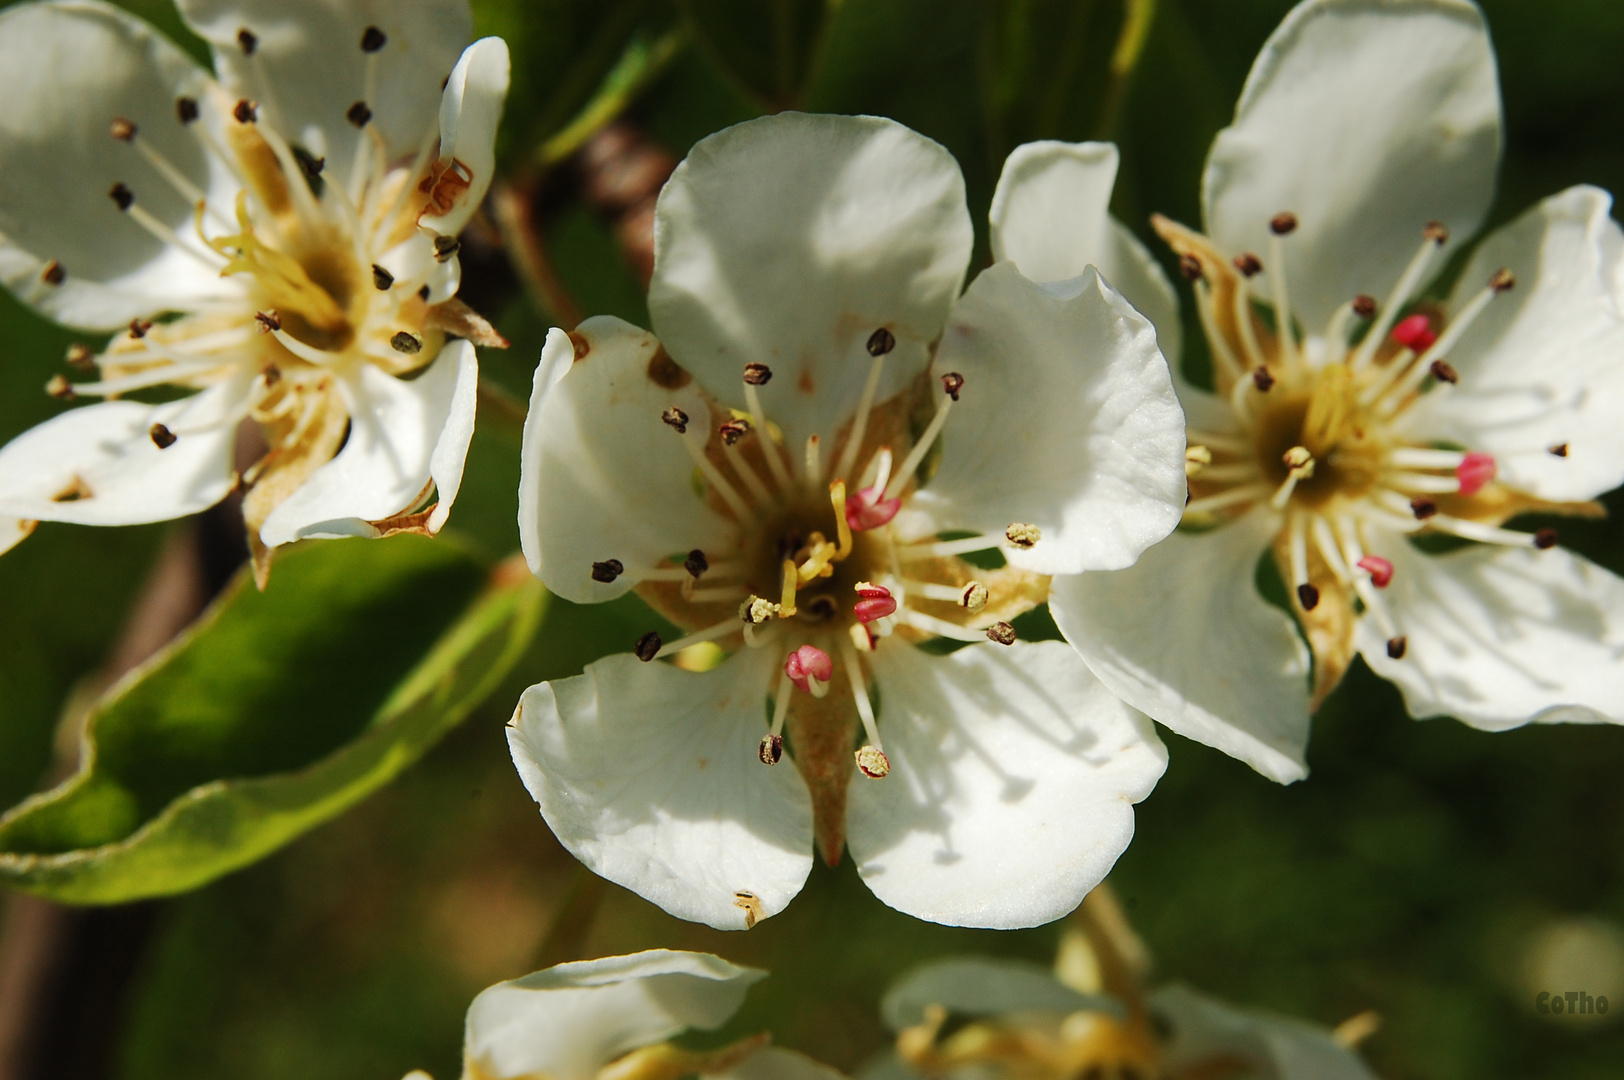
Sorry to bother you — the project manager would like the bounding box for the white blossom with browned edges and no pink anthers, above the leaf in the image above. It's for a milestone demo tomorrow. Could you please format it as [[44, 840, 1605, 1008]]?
[[0, 0, 508, 583]]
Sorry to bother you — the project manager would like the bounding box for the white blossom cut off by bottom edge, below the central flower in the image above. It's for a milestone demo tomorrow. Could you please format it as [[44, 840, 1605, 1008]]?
[[406, 948, 841, 1080]]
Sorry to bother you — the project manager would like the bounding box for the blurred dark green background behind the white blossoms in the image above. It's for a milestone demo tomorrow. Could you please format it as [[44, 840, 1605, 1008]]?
[[0, 0, 1624, 1080]]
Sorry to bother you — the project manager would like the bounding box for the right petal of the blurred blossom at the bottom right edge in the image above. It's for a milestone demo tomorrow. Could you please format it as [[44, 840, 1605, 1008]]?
[[1150, 984, 1376, 1080]]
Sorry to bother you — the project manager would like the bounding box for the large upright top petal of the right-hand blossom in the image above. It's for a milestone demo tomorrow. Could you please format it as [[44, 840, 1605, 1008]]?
[[1202, 0, 1501, 331]]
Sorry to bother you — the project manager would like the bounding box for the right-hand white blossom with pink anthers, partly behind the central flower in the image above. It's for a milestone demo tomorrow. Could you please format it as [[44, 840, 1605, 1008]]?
[[992, 0, 1624, 781]]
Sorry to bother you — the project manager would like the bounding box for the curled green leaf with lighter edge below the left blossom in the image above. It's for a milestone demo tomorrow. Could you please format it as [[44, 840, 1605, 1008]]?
[[0, 536, 546, 903]]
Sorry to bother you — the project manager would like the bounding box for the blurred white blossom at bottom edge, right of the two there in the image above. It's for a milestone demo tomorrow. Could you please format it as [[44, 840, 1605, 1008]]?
[[859, 885, 1379, 1080]]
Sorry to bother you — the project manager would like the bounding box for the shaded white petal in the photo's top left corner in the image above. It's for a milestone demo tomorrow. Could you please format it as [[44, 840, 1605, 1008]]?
[[0, 3, 240, 330]]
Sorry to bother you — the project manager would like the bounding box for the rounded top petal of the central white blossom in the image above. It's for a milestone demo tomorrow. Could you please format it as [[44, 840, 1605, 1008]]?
[[648, 112, 973, 451]]
